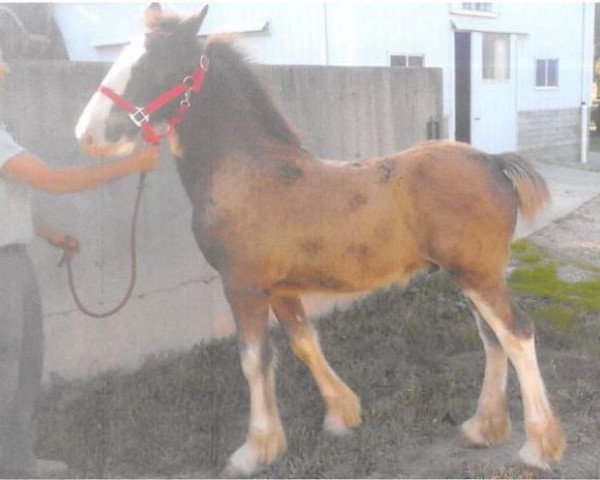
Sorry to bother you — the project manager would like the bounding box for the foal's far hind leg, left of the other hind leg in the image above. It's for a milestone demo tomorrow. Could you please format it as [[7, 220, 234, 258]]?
[[462, 306, 511, 447]]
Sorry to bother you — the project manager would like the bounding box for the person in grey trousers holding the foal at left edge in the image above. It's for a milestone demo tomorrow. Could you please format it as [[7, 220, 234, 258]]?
[[0, 45, 159, 478]]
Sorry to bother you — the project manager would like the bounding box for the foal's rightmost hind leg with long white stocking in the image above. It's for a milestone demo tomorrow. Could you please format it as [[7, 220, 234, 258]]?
[[465, 285, 566, 470]]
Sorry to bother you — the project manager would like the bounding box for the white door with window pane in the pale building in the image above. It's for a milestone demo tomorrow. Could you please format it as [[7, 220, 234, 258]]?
[[471, 32, 517, 153]]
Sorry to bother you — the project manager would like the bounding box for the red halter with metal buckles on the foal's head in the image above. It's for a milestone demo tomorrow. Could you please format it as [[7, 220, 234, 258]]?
[[98, 55, 208, 144]]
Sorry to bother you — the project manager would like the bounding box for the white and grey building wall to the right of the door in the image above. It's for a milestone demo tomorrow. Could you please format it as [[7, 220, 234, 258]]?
[[504, 2, 594, 165]]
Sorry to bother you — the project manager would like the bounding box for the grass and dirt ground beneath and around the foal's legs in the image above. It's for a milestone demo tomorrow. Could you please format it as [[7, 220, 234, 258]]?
[[37, 196, 600, 478]]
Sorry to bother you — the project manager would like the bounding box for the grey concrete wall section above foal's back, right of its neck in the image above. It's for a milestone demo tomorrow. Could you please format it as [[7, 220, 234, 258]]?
[[259, 66, 442, 160]]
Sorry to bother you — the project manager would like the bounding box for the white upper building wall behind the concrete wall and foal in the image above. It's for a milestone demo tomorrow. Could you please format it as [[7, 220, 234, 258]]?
[[55, 1, 594, 165]]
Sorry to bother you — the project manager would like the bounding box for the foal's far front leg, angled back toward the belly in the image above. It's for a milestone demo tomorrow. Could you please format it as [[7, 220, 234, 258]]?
[[271, 297, 360, 434]]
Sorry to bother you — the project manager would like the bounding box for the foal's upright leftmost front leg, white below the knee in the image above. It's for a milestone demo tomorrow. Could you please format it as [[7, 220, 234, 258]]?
[[224, 289, 286, 477]]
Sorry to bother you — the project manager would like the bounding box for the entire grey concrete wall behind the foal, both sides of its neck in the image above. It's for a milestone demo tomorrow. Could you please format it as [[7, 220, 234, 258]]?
[[0, 62, 442, 377]]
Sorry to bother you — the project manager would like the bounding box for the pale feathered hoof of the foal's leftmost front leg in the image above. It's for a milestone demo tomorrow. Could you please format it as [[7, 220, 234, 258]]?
[[221, 431, 287, 478]]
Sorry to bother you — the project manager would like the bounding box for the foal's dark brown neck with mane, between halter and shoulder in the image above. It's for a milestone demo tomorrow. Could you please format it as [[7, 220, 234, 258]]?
[[181, 36, 301, 176]]
